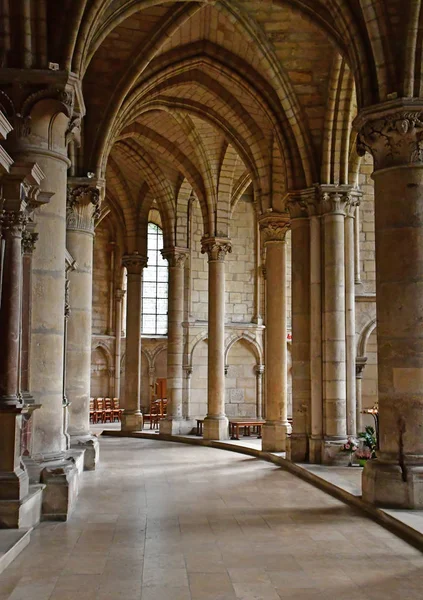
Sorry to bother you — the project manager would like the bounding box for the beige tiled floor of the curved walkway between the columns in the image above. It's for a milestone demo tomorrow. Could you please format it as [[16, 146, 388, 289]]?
[[0, 438, 423, 600]]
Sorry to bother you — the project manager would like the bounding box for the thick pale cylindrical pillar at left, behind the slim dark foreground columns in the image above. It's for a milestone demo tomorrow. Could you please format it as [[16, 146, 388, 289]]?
[[7, 112, 71, 462]]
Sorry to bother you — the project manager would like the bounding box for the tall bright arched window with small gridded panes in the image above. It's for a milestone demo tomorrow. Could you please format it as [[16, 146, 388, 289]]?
[[141, 223, 168, 335]]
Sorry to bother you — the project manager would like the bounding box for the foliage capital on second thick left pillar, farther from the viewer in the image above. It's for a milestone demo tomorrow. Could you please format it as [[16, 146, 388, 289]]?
[[66, 185, 101, 233]]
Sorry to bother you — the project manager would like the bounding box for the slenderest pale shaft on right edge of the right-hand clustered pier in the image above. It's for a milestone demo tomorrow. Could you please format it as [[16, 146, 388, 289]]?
[[345, 196, 360, 436]]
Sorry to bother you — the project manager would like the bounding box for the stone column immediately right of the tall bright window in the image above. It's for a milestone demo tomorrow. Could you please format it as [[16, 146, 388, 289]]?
[[160, 248, 189, 435]]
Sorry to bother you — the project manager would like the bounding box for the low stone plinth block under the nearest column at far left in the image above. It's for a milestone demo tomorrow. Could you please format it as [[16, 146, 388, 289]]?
[[0, 485, 45, 529]]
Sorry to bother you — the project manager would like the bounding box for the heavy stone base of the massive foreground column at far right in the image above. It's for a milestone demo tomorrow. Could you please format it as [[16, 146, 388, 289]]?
[[362, 459, 423, 510]]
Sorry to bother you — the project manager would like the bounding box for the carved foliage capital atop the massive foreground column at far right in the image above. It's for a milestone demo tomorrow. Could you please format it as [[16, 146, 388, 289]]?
[[354, 98, 423, 171]]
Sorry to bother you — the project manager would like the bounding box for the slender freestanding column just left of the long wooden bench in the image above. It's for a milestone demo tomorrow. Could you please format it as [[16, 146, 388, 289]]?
[[201, 238, 232, 440]]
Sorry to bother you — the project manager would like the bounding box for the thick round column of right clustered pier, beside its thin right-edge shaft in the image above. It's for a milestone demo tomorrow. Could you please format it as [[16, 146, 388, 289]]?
[[321, 185, 351, 463]]
